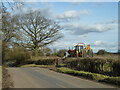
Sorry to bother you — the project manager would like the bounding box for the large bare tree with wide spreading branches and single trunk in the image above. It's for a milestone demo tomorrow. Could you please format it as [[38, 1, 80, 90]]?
[[14, 11, 61, 56]]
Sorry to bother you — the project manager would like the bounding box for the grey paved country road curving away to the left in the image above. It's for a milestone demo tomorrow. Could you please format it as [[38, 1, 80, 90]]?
[[8, 67, 116, 88]]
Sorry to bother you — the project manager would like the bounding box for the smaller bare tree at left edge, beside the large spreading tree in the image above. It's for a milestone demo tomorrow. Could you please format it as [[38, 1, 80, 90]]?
[[0, 13, 20, 61]]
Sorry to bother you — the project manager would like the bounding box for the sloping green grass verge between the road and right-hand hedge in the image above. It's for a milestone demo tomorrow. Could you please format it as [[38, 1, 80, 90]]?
[[54, 67, 120, 86]]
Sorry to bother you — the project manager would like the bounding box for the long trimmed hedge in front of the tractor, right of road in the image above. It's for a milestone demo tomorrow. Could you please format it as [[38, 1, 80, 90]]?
[[66, 58, 120, 76]]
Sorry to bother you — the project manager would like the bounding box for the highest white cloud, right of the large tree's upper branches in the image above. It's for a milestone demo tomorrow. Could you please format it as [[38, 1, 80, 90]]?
[[55, 10, 91, 21]]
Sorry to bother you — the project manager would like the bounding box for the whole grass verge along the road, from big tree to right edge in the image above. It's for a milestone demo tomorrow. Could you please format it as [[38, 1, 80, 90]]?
[[21, 64, 120, 86]]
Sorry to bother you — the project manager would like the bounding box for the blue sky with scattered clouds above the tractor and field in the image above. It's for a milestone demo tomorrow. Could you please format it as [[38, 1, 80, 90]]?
[[6, 2, 118, 52]]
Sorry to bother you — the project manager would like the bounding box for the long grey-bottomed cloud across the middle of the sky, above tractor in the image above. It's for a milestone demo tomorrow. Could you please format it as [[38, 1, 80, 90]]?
[[64, 23, 114, 35]]
